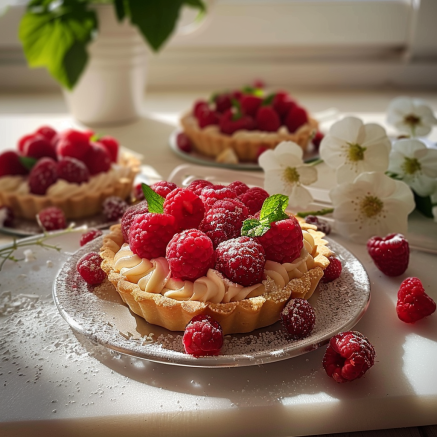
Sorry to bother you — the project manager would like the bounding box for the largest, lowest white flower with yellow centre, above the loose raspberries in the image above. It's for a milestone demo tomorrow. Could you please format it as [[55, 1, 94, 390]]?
[[329, 172, 415, 242]]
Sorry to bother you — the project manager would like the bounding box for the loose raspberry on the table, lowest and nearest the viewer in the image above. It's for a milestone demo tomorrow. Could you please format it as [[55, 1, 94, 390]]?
[[323, 331, 375, 382]]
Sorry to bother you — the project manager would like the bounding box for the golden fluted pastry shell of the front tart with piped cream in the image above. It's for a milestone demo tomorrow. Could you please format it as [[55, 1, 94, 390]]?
[[100, 221, 332, 334]]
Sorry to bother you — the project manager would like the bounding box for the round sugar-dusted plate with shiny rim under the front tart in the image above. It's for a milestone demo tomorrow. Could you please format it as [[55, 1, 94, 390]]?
[[53, 237, 370, 367]]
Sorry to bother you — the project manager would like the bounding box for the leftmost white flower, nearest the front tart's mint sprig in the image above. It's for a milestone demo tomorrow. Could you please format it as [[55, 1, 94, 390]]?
[[258, 141, 317, 209]]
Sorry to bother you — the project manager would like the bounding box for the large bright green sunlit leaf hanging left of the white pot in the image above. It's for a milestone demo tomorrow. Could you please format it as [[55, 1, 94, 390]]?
[[19, 0, 97, 89]]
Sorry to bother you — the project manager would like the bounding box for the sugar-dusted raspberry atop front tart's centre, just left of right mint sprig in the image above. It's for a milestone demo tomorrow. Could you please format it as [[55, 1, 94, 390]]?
[[199, 199, 249, 247]]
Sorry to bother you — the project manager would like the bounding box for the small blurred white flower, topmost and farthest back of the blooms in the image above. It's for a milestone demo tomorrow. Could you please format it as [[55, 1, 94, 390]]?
[[387, 97, 437, 137]]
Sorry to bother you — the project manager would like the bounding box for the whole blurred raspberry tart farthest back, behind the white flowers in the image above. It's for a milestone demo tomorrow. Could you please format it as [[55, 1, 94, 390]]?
[[180, 87, 318, 164]]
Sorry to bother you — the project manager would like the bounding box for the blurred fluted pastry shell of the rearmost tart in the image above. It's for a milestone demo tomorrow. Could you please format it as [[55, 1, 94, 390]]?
[[181, 113, 318, 162]]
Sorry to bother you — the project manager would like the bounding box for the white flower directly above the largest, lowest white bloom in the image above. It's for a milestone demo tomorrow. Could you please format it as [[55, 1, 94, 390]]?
[[320, 117, 391, 184]]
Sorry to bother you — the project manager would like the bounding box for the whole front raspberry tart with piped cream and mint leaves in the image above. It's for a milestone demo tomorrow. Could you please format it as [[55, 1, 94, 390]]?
[[100, 183, 333, 335]]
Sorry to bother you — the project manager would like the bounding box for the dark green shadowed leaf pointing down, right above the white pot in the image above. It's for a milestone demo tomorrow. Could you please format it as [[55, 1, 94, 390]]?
[[126, 0, 183, 51]]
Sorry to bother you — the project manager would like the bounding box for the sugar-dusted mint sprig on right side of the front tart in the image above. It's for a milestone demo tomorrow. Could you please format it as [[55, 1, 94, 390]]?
[[241, 194, 288, 237]]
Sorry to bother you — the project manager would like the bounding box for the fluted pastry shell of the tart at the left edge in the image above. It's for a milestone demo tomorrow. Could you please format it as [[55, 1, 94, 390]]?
[[0, 154, 140, 220]]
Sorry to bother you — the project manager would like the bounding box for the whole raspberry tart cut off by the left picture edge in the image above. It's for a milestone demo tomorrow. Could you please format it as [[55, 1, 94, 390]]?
[[0, 126, 140, 220]]
